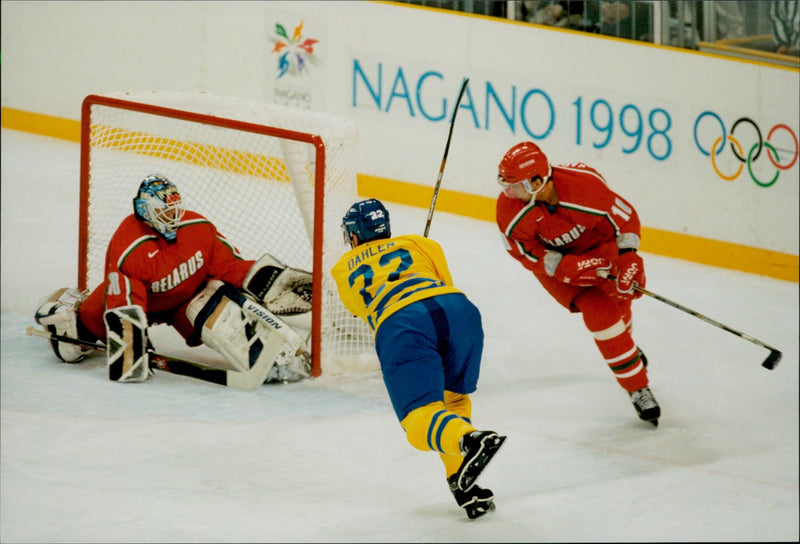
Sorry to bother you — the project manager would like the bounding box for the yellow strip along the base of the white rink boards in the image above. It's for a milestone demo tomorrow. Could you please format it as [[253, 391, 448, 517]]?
[[0, 108, 800, 282]]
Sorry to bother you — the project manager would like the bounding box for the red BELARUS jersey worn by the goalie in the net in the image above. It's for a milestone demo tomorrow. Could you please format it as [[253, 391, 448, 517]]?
[[79, 210, 254, 345]]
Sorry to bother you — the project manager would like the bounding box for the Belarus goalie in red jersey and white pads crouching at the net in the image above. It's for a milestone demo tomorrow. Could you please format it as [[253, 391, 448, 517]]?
[[35, 174, 311, 382]]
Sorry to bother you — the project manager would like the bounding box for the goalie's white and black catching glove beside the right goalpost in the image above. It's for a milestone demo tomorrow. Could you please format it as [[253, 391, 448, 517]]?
[[242, 253, 312, 316]]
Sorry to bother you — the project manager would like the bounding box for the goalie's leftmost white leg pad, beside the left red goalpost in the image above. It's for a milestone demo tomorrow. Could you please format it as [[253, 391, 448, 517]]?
[[34, 287, 86, 363]]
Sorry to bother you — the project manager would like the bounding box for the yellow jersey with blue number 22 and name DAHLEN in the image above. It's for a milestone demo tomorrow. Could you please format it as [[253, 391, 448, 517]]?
[[331, 234, 461, 332]]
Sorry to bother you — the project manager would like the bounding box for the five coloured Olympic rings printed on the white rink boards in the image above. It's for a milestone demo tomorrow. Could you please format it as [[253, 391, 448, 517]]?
[[694, 111, 800, 187]]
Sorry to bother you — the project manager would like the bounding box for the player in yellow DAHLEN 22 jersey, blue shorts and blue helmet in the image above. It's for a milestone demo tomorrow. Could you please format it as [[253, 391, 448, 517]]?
[[331, 199, 506, 519]]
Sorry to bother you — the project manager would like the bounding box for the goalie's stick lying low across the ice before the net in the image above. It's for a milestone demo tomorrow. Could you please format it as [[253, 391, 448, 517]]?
[[25, 327, 264, 391]]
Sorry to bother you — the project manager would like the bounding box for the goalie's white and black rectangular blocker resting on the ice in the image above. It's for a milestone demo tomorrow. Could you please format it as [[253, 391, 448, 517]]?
[[103, 305, 150, 382]]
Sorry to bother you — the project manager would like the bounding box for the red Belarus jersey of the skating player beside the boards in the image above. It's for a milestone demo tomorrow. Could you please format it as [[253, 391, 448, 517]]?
[[497, 163, 641, 275]]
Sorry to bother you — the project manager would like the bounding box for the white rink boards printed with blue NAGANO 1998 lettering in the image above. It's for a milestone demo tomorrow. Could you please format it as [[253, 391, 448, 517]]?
[[2, 1, 800, 255]]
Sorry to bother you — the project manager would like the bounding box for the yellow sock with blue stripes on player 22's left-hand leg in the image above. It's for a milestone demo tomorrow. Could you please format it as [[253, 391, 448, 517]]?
[[400, 401, 475, 456]]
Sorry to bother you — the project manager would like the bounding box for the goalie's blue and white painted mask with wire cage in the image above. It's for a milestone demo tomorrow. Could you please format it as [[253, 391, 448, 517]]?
[[133, 174, 184, 242]]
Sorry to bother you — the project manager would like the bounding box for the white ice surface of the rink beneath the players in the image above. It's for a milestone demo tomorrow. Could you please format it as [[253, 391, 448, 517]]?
[[0, 129, 800, 544]]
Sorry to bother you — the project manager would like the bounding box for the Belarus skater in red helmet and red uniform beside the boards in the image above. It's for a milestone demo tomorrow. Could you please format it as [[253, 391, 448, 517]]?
[[497, 142, 661, 425]]
